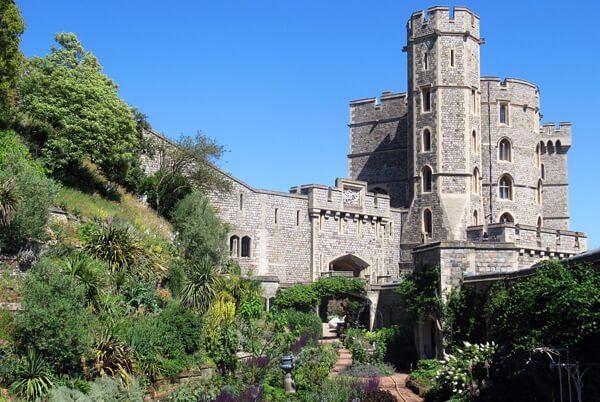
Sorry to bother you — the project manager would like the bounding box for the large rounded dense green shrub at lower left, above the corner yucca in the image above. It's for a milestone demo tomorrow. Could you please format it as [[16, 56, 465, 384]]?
[[13, 258, 94, 373]]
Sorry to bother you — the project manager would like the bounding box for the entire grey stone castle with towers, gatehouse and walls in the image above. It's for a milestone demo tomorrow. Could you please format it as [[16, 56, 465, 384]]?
[[142, 7, 587, 352]]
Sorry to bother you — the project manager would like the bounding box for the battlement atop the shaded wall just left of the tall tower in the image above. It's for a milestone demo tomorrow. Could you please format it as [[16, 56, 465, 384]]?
[[350, 92, 407, 124]]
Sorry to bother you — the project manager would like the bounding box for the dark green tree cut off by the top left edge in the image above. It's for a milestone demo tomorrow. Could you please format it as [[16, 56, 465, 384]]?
[[0, 0, 25, 106]]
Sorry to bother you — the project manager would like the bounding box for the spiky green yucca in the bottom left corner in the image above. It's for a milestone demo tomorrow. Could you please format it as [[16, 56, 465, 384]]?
[[10, 350, 54, 401]]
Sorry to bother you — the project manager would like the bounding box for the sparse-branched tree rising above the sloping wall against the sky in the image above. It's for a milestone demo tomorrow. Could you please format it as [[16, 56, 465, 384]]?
[[144, 132, 230, 217]]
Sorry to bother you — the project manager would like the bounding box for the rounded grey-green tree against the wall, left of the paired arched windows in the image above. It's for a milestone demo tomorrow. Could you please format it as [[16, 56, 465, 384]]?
[[172, 191, 228, 265]]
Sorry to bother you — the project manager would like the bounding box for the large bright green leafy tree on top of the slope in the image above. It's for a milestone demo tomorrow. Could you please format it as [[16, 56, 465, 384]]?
[[18, 33, 139, 183]]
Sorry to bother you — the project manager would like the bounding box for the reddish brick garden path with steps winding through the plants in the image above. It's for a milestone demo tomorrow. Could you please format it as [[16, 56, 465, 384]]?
[[321, 323, 423, 402]]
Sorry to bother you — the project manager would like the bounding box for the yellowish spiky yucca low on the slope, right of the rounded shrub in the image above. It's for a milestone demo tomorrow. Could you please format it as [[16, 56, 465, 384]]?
[[92, 330, 137, 386]]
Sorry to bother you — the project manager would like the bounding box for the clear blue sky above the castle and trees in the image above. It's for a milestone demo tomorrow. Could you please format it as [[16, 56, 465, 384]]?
[[17, 0, 600, 248]]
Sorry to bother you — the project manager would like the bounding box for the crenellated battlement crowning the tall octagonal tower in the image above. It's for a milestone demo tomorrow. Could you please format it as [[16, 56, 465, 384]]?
[[406, 6, 479, 41]]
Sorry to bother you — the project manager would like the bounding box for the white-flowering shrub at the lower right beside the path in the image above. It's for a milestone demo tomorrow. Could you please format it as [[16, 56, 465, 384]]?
[[436, 342, 496, 401]]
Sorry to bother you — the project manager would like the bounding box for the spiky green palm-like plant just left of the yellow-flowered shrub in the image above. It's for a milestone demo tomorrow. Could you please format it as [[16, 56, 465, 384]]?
[[181, 255, 219, 313]]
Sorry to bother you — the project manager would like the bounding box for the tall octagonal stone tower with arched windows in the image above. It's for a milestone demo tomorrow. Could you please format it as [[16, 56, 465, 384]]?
[[402, 7, 484, 250]]
